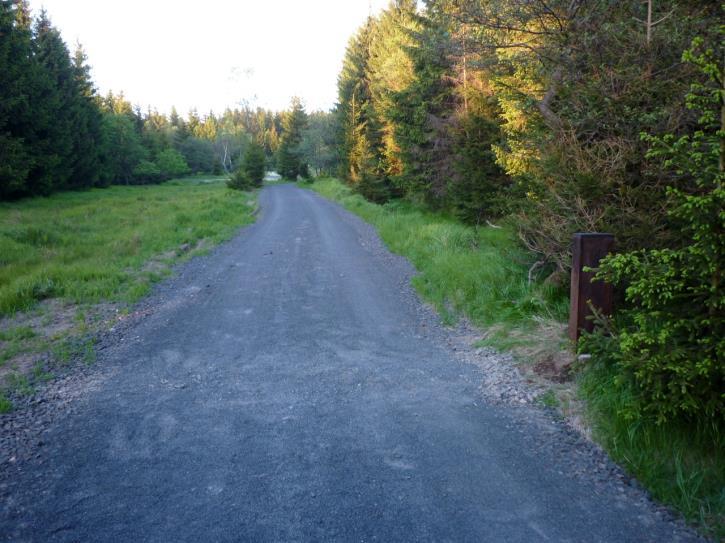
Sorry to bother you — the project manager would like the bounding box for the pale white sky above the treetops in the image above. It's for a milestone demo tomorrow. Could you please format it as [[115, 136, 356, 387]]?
[[30, 0, 388, 115]]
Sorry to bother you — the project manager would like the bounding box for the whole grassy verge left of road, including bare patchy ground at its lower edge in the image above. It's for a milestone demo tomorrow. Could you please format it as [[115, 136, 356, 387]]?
[[0, 177, 255, 411]]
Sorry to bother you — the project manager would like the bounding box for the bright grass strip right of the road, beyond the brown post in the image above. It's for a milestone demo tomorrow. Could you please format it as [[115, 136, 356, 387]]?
[[311, 179, 568, 338]]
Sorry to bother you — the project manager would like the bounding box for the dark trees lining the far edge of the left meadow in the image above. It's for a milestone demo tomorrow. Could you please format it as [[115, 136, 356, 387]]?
[[0, 4, 292, 199]]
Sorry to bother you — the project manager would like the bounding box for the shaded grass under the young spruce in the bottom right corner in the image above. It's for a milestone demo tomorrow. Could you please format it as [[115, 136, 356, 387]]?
[[579, 361, 725, 540]]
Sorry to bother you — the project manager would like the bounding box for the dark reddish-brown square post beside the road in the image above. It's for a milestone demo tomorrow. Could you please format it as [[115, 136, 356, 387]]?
[[569, 233, 614, 342]]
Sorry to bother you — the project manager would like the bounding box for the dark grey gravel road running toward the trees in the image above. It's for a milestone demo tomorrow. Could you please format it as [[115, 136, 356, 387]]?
[[0, 185, 698, 542]]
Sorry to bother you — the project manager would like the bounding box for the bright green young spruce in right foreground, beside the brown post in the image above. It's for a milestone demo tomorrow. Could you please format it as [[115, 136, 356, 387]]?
[[584, 33, 725, 424]]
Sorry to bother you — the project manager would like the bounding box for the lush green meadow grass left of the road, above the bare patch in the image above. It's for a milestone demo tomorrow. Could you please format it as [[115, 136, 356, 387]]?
[[0, 179, 254, 316]]
